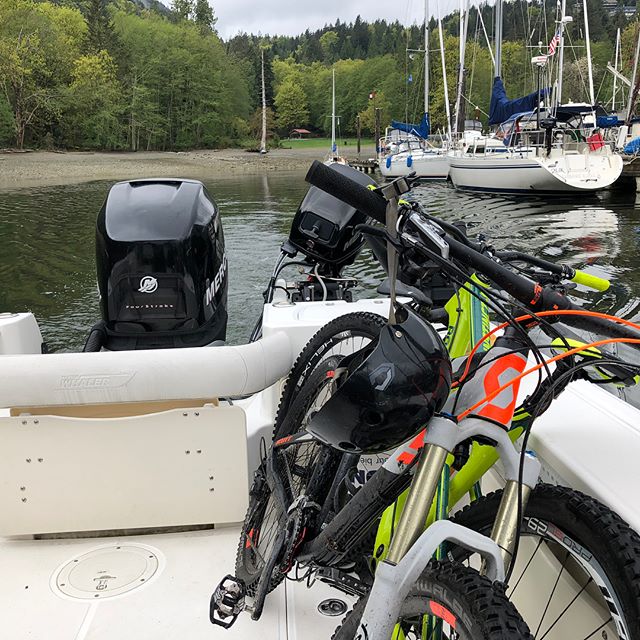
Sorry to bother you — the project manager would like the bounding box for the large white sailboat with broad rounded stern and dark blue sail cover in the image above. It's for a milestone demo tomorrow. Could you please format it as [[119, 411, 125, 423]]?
[[449, 0, 622, 194]]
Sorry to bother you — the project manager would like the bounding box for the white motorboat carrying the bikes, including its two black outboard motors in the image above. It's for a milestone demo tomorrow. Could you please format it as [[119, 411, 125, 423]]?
[[0, 166, 640, 640]]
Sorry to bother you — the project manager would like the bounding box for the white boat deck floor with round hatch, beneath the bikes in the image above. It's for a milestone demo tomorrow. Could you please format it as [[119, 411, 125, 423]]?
[[0, 526, 353, 640]]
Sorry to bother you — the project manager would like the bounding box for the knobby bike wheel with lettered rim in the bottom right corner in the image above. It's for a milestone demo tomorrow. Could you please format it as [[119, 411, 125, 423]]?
[[452, 484, 640, 640]]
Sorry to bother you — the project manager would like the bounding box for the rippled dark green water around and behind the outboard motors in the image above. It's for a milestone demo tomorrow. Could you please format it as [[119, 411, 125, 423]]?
[[0, 173, 640, 350]]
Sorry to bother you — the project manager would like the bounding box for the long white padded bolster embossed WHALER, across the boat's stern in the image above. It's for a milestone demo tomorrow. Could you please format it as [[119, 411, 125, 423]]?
[[0, 331, 295, 407]]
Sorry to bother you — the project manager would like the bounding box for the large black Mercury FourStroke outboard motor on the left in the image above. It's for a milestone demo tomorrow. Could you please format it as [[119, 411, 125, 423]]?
[[84, 179, 227, 351]]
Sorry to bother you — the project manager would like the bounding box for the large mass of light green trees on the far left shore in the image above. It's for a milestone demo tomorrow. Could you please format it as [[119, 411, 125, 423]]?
[[0, 0, 253, 150]]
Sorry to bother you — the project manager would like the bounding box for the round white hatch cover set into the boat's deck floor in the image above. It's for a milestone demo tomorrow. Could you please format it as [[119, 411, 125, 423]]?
[[51, 544, 162, 601]]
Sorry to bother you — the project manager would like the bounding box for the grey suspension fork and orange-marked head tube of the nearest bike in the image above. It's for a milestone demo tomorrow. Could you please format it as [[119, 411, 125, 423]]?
[[359, 329, 540, 640]]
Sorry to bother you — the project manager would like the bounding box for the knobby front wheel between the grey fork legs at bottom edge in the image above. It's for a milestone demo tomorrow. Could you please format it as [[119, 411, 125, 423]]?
[[332, 561, 531, 640]]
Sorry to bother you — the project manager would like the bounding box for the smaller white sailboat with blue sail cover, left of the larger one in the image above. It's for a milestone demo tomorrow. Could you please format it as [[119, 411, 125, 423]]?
[[378, 1, 451, 180]]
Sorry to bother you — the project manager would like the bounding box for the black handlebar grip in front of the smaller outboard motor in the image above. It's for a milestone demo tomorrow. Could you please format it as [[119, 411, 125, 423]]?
[[305, 160, 387, 224]]
